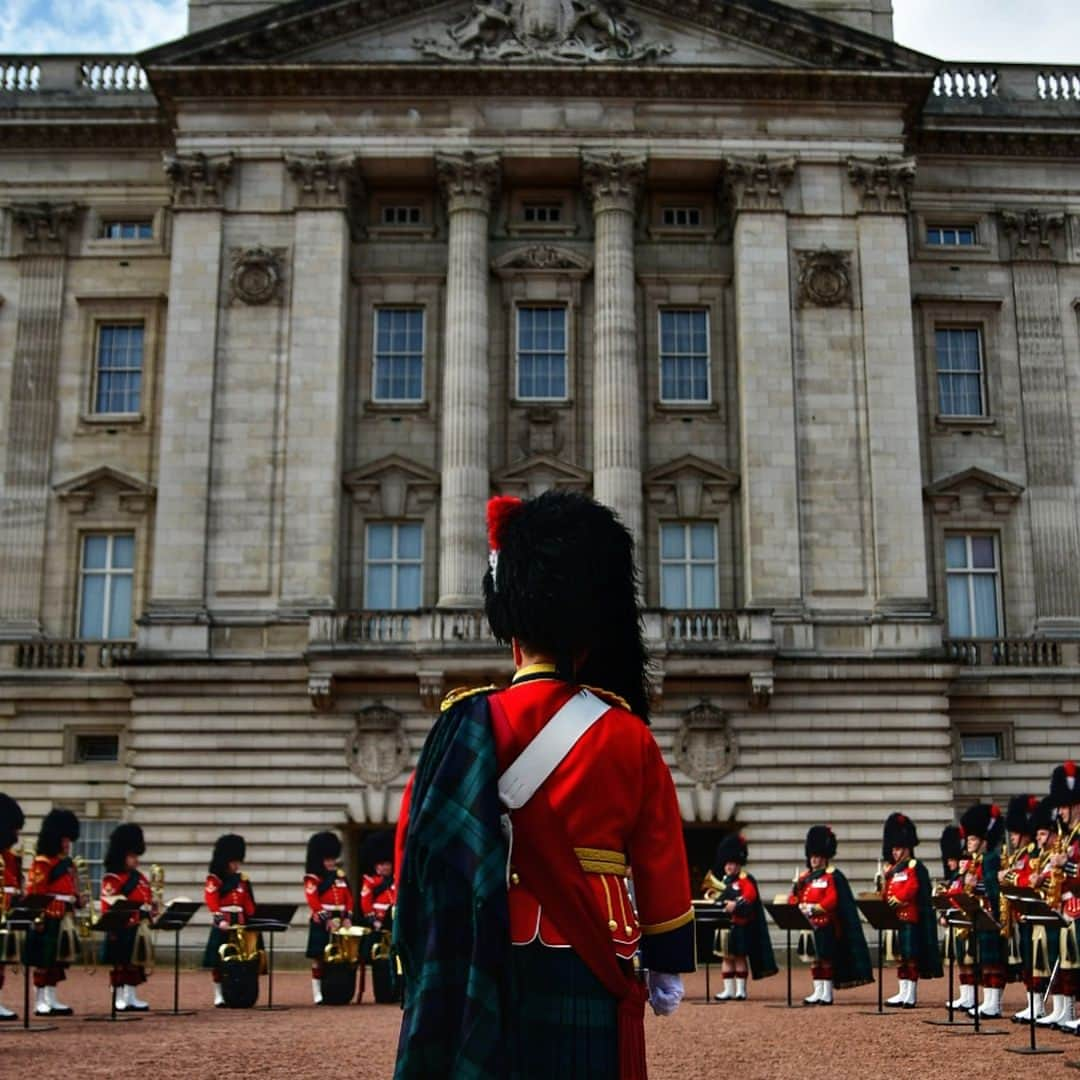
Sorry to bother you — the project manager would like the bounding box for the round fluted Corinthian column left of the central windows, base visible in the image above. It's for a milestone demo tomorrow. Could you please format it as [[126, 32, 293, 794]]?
[[435, 150, 499, 607]]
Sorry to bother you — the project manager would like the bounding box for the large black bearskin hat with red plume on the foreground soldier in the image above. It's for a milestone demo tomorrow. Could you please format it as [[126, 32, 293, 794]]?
[[484, 491, 649, 723]]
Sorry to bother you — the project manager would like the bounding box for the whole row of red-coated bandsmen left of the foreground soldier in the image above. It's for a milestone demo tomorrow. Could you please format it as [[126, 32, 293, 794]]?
[[0, 793, 395, 1021]]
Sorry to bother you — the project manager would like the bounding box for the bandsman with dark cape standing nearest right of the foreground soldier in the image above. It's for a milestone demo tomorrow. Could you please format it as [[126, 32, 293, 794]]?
[[704, 833, 777, 1001]]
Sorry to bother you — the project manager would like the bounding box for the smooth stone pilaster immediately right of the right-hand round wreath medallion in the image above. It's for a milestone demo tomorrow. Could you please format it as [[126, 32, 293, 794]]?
[[848, 158, 930, 615]]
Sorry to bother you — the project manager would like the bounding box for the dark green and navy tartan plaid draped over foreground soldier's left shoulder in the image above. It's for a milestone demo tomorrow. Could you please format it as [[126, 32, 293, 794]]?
[[394, 694, 511, 1080]]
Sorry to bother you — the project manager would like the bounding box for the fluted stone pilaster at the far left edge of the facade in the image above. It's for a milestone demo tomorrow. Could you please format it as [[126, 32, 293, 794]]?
[[0, 203, 77, 638]]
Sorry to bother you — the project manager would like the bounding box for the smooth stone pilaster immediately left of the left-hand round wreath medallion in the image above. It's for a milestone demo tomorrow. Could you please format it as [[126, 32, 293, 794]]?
[[139, 154, 232, 652]]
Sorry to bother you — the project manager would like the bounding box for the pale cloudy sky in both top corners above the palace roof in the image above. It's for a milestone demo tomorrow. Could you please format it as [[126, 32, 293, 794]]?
[[0, 0, 1080, 64]]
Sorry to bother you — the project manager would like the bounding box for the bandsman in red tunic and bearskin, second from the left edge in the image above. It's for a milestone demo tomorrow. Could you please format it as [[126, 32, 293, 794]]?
[[26, 810, 82, 1016]]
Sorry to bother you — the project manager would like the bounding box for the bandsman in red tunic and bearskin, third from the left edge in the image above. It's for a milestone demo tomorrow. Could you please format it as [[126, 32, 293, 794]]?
[[102, 824, 154, 1012]]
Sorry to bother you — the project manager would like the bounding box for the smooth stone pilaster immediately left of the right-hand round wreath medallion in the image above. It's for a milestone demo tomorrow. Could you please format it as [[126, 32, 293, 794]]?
[[724, 154, 802, 611]]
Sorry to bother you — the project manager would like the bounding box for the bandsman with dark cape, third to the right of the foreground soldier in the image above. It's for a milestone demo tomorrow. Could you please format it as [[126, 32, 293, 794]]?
[[882, 813, 942, 1009]]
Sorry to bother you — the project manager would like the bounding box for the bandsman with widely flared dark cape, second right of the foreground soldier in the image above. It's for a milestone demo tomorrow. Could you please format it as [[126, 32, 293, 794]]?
[[787, 825, 874, 1005]]
